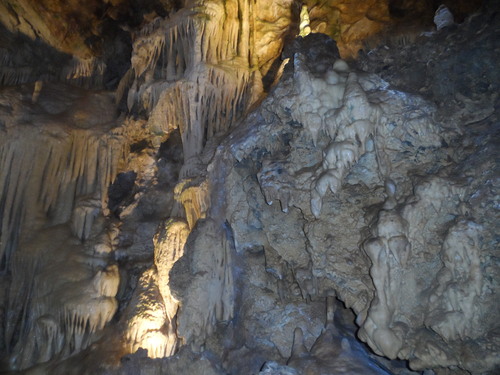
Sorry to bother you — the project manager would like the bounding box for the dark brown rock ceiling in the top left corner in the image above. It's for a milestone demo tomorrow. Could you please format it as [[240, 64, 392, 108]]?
[[0, 0, 179, 58]]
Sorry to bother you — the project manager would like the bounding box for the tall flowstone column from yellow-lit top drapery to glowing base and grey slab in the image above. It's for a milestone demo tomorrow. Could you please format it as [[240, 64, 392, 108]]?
[[110, 0, 291, 366]]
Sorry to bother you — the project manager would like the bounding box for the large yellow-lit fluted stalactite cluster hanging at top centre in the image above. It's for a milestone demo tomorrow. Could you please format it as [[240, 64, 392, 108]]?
[[124, 0, 259, 158]]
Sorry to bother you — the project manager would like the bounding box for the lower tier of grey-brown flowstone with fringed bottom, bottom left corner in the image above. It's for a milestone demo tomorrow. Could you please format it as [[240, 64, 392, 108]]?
[[5, 225, 120, 369]]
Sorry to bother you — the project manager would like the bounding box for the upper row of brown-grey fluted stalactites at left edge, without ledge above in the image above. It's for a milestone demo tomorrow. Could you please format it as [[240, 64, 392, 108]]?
[[0, 128, 123, 267]]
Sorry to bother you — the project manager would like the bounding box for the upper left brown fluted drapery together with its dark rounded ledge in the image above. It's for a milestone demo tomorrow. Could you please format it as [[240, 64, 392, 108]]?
[[0, 85, 124, 268]]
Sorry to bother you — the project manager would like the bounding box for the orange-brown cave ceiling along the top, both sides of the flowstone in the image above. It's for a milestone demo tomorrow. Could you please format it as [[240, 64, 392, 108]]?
[[0, 0, 481, 58]]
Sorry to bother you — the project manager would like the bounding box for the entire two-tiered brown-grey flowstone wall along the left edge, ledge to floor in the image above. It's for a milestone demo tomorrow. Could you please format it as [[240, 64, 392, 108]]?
[[0, 83, 124, 369]]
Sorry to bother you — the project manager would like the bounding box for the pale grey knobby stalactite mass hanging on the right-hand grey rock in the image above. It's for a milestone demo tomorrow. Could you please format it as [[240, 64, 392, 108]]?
[[259, 54, 380, 217]]
